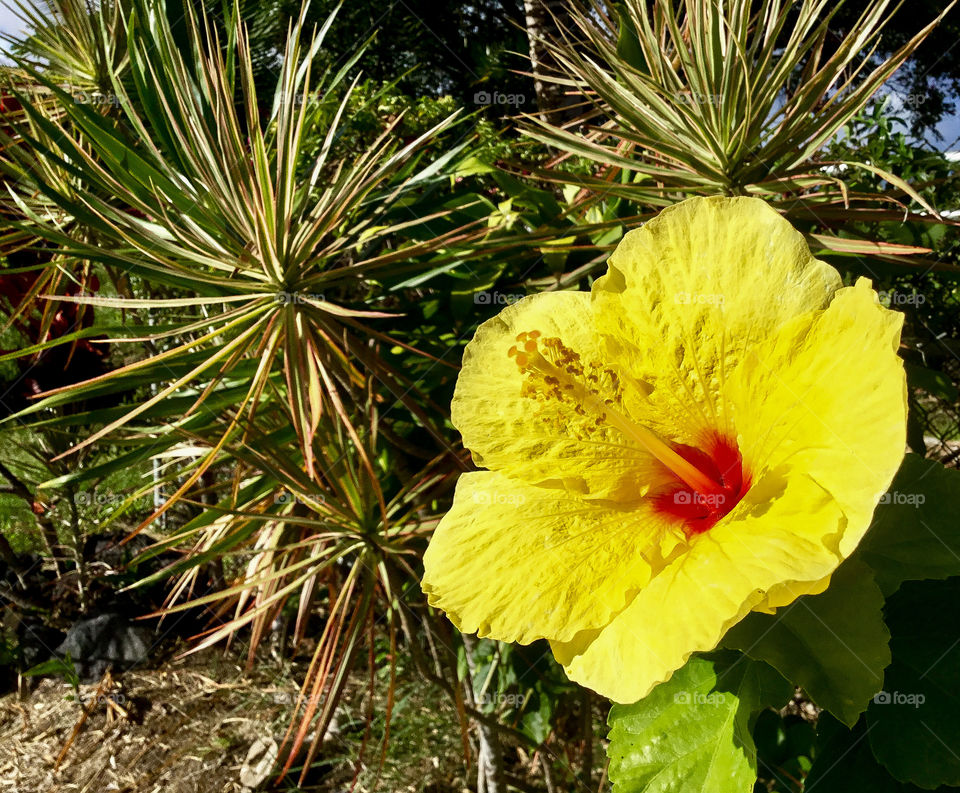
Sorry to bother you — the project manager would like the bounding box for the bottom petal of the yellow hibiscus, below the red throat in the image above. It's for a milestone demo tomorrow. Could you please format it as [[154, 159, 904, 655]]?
[[551, 472, 844, 702]]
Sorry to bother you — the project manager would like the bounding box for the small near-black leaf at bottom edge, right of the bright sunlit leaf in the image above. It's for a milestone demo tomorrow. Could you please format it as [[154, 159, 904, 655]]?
[[803, 714, 947, 793]]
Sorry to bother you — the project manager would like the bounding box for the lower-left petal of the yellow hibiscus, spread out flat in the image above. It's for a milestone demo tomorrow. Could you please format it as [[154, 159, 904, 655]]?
[[422, 471, 676, 643]]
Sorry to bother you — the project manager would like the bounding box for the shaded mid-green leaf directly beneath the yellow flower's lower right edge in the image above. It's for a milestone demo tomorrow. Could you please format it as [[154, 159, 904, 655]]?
[[723, 560, 890, 725]]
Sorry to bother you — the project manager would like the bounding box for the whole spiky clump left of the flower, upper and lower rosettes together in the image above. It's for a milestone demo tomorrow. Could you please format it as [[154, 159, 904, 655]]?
[[4, 0, 489, 769]]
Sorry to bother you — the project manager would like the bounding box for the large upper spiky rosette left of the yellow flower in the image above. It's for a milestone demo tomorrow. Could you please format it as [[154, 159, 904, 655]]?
[[0, 2, 483, 508]]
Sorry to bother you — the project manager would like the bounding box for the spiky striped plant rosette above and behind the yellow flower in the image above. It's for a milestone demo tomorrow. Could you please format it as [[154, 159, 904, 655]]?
[[524, 0, 952, 266]]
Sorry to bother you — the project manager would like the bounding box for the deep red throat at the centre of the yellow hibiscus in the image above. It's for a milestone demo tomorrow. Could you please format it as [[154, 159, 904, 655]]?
[[654, 435, 750, 536]]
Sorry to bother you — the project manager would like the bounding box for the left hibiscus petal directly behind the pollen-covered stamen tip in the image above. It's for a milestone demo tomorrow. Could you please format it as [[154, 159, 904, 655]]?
[[451, 292, 676, 500]]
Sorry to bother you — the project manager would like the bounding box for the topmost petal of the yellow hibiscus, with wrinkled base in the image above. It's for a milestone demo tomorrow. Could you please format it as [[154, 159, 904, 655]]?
[[593, 197, 841, 443]]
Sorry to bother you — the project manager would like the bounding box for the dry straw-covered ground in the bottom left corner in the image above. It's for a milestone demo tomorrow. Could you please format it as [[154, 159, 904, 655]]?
[[0, 648, 296, 793]]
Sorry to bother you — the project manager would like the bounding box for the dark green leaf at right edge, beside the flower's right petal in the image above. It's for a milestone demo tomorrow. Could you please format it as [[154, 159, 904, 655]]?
[[856, 454, 960, 595]]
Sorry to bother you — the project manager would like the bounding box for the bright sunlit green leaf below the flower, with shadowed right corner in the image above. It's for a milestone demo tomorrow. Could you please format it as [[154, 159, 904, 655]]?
[[607, 653, 793, 793]]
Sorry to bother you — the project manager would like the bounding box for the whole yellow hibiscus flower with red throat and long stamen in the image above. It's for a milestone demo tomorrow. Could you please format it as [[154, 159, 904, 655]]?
[[423, 198, 906, 702]]
